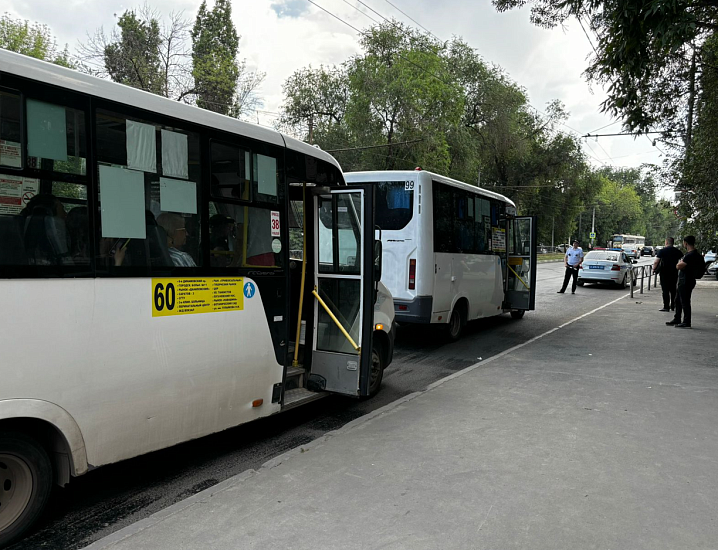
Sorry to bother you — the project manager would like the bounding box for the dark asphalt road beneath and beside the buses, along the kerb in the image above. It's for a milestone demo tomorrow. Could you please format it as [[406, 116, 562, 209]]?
[[10, 258, 652, 550]]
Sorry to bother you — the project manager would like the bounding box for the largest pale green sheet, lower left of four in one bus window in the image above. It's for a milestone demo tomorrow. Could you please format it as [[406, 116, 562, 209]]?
[[100, 166, 147, 239]]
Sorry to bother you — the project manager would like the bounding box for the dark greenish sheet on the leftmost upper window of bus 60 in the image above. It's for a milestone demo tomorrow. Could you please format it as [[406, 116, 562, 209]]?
[[26, 99, 67, 161]]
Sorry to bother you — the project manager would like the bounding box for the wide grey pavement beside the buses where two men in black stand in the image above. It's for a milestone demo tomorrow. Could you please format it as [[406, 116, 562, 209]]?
[[88, 281, 718, 550]]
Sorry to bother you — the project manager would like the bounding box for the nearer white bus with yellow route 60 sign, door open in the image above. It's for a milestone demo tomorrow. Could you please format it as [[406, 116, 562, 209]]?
[[0, 50, 394, 546]]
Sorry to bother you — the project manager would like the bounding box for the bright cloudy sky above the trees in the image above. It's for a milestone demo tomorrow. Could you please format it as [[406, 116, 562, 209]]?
[[3, 0, 663, 175]]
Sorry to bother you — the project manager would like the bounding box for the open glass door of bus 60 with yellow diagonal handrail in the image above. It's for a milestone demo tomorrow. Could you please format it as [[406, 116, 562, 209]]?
[[309, 184, 376, 396]]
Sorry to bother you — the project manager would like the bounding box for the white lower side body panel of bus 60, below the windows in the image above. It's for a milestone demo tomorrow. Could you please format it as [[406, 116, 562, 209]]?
[[0, 278, 283, 473]]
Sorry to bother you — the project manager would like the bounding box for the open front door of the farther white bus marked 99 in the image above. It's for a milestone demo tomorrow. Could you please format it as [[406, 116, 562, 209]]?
[[504, 216, 537, 316]]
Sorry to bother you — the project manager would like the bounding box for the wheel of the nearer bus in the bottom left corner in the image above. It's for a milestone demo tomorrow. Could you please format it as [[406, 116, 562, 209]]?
[[0, 433, 52, 547]]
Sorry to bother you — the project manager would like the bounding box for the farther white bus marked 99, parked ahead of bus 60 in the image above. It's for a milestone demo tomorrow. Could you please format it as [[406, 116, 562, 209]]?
[[344, 170, 536, 339]]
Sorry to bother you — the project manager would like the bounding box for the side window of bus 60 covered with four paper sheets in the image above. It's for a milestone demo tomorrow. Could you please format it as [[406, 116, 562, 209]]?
[[96, 109, 202, 270]]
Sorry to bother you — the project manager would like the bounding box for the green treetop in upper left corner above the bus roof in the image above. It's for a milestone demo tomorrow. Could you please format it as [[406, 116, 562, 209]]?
[[0, 13, 75, 69]]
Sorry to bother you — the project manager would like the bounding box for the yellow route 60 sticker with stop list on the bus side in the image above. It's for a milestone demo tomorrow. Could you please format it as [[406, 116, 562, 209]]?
[[152, 277, 244, 317]]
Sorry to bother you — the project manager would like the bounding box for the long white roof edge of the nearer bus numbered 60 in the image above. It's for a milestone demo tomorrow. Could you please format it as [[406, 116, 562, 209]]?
[[0, 49, 341, 174]]
